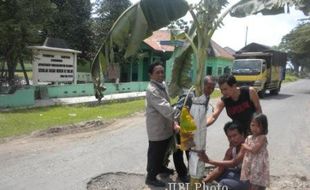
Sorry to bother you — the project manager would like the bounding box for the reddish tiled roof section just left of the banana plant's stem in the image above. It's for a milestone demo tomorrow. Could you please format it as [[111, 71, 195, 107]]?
[[144, 30, 174, 52]]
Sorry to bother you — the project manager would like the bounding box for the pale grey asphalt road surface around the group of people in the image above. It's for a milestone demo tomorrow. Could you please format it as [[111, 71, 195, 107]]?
[[0, 79, 310, 190]]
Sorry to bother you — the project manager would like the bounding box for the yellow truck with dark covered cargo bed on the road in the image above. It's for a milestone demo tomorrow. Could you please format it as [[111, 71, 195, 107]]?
[[232, 43, 286, 98]]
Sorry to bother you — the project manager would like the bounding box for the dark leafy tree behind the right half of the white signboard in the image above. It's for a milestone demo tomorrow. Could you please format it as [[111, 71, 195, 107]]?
[[44, 0, 94, 61]]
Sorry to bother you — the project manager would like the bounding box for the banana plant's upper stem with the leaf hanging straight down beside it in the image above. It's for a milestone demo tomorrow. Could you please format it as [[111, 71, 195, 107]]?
[[169, 0, 229, 97]]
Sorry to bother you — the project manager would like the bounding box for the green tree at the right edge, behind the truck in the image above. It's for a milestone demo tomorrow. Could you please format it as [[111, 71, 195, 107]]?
[[280, 22, 310, 73]]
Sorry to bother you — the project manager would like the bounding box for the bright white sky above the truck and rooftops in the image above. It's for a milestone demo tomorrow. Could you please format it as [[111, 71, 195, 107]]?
[[131, 0, 305, 50]]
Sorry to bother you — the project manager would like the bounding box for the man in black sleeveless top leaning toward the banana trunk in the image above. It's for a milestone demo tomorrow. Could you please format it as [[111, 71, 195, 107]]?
[[207, 75, 262, 135]]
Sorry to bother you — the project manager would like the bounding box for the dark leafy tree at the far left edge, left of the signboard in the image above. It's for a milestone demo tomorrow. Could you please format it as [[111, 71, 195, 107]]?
[[0, 0, 52, 86]]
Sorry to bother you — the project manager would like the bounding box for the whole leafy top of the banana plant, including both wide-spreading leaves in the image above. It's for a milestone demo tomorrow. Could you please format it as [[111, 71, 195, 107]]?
[[91, 0, 310, 100]]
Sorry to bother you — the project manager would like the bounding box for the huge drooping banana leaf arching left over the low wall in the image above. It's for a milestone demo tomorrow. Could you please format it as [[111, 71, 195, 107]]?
[[91, 0, 189, 100]]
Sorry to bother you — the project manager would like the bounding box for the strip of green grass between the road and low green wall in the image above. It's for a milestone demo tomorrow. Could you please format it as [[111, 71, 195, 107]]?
[[0, 89, 220, 138]]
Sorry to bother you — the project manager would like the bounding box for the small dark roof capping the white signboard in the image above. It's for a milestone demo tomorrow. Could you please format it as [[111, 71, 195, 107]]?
[[29, 38, 81, 53]]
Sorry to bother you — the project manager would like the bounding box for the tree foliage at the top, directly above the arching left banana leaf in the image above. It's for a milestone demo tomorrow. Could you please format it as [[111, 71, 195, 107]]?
[[93, 0, 131, 48]]
